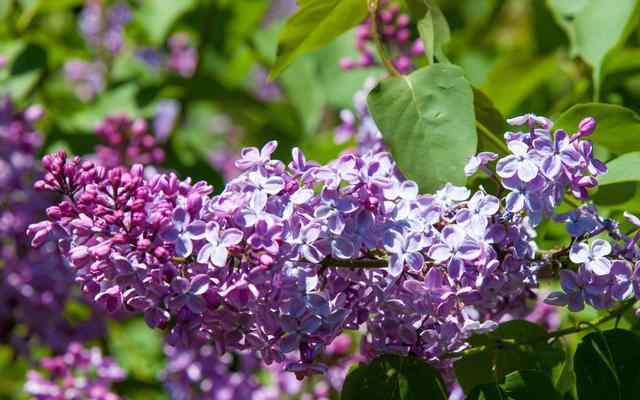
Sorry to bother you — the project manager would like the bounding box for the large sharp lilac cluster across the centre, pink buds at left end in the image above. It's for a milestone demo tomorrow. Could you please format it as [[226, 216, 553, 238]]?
[[29, 133, 538, 376]]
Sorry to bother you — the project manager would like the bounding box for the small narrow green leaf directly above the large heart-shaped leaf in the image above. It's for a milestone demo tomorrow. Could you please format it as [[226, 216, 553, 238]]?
[[411, 0, 451, 63]]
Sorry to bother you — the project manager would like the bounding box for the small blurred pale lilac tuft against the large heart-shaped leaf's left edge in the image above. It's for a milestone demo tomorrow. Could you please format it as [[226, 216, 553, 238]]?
[[334, 78, 386, 154]]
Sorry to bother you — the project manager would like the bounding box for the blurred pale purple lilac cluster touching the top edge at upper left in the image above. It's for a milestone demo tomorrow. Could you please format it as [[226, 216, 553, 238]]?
[[79, 0, 131, 55]]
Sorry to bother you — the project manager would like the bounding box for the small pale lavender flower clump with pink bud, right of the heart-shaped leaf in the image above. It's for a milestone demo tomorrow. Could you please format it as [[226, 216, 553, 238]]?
[[465, 114, 607, 225]]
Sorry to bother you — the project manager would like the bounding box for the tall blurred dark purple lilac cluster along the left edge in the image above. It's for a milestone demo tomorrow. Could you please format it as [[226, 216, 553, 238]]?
[[0, 98, 104, 354]]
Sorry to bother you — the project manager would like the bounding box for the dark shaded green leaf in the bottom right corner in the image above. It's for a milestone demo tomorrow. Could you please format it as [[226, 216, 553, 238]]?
[[574, 329, 640, 400]]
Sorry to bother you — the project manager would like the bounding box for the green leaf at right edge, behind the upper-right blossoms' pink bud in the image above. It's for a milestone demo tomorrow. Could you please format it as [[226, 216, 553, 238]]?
[[555, 103, 640, 154]]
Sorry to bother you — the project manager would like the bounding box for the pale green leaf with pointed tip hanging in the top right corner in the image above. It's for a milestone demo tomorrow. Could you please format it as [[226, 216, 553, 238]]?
[[547, 0, 640, 99]]
